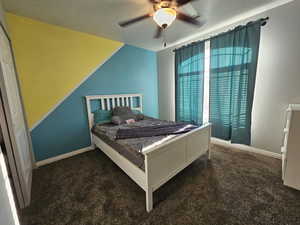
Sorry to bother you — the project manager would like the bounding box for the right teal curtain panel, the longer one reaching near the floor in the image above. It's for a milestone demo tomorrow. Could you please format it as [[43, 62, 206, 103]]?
[[209, 21, 261, 145]]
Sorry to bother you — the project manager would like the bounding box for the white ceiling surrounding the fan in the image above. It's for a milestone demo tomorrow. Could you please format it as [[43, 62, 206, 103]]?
[[4, 0, 282, 51]]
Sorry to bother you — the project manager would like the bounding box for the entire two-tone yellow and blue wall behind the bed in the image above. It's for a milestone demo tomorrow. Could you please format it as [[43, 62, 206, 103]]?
[[7, 14, 158, 161]]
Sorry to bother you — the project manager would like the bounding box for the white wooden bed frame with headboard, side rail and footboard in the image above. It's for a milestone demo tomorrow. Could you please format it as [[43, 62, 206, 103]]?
[[85, 94, 211, 212]]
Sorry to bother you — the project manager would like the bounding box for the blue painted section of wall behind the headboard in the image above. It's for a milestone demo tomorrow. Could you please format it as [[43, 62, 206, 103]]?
[[31, 45, 158, 161]]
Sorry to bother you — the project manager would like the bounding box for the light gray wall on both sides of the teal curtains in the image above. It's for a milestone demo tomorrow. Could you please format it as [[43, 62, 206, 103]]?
[[157, 0, 300, 153]]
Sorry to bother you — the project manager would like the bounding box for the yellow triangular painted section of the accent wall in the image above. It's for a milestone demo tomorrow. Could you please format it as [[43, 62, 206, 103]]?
[[6, 13, 123, 128]]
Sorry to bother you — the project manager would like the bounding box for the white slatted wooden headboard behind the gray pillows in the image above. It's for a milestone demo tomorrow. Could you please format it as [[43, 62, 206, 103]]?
[[85, 94, 143, 142]]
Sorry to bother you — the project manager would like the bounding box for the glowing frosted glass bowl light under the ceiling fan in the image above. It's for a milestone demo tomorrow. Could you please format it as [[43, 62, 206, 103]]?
[[153, 8, 176, 28]]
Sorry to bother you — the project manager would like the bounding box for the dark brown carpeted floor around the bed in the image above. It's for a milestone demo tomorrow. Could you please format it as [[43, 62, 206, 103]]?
[[21, 146, 300, 225]]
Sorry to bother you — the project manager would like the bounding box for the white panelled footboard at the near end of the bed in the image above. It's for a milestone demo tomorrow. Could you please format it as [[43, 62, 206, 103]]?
[[143, 124, 211, 212]]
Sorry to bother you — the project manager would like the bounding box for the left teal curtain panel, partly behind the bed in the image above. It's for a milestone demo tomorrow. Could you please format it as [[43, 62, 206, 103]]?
[[175, 42, 204, 125]]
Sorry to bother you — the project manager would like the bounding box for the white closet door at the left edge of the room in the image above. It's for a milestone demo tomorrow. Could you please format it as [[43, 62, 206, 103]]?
[[0, 23, 33, 207]]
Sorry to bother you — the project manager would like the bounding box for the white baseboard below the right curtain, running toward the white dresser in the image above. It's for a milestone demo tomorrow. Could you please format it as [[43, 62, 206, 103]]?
[[211, 138, 281, 159]]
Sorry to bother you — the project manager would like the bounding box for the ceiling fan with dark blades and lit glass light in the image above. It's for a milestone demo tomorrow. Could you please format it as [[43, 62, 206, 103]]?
[[119, 0, 203, 38]]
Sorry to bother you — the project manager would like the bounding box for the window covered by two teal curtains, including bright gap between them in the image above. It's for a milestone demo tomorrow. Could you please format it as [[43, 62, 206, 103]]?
[[175, 20, 262, 145]]
